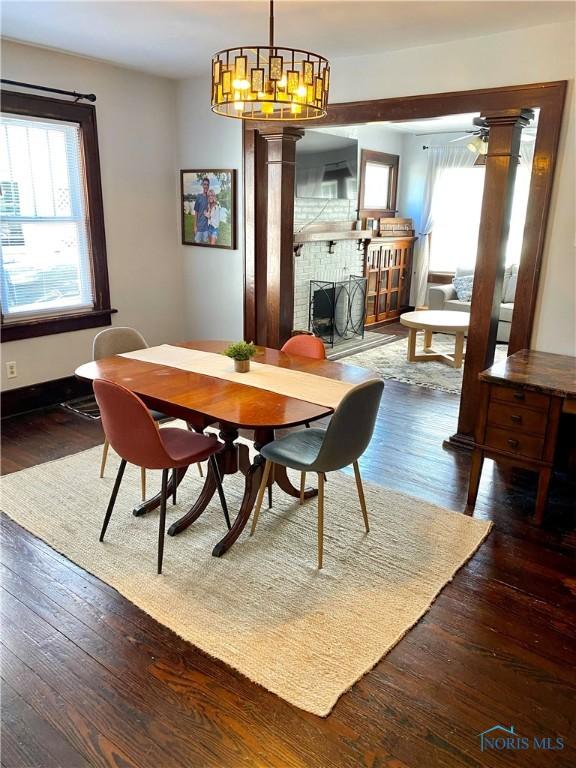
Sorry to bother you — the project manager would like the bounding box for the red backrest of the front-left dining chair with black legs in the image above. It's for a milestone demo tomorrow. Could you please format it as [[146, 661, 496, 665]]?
[[94, 379, 173, 469]]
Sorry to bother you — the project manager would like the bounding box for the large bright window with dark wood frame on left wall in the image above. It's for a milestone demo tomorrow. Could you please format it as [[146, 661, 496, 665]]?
[[0, 92, 112, 341]]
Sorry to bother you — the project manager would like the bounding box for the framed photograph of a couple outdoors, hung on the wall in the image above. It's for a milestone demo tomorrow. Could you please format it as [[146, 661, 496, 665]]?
[[180, 168, 236, 249]]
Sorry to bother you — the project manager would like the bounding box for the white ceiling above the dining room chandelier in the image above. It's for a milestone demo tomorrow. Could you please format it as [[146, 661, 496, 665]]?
[[2, 0, 574, 78]]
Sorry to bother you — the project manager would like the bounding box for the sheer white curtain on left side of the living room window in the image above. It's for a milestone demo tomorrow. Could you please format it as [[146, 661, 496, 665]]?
[[412, 144, 476, 307]]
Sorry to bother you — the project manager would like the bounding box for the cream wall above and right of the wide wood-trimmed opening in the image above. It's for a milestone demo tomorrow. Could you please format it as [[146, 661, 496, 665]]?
[[330, 24, 576, 354]]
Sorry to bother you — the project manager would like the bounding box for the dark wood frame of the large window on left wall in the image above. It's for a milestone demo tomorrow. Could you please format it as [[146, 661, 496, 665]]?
[[1, 89, 116, 342]]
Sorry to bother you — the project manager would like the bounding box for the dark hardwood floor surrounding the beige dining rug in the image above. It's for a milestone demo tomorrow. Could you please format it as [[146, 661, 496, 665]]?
[[1, 382, 576, 768]]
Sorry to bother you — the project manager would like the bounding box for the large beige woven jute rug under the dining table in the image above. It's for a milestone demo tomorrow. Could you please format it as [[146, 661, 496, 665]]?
[[2, 428, 490, 716]]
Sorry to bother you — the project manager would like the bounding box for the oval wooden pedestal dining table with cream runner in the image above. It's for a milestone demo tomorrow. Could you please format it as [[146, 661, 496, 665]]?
[[75, 340, 374, 557]]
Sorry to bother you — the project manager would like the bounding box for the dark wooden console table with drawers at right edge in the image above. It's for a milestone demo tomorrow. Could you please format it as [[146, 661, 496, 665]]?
[[468, 349, 576, 525]]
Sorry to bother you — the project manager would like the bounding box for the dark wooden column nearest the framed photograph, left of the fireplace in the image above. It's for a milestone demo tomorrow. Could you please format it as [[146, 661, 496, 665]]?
[[256, 128, 304, 348]]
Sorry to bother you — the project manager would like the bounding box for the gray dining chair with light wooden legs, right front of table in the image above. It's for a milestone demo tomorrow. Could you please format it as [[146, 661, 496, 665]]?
[[250, 379, 384, 568]]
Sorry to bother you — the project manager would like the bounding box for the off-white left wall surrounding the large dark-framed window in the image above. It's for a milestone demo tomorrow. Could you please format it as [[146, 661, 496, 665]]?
[[2, 42, 187, 389]]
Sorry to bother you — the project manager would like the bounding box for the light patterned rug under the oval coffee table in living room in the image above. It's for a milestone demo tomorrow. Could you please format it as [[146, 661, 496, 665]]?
[[345, 333, 508, 393]]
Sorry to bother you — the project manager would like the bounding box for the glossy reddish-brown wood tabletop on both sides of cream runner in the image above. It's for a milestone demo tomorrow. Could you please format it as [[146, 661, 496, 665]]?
[[75, 341, 374, 429]]
